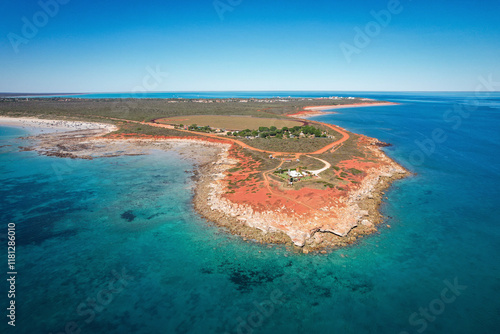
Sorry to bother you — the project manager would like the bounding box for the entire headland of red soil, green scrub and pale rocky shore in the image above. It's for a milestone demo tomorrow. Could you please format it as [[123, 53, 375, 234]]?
[[0, 98, 409, 253]]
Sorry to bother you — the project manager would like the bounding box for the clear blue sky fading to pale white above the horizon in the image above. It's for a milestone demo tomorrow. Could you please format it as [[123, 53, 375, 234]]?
[[0, 0, 500, 92]]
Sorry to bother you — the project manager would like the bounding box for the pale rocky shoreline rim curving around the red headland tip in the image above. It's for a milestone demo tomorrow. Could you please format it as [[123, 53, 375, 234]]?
[[194, 140, 410, 253]]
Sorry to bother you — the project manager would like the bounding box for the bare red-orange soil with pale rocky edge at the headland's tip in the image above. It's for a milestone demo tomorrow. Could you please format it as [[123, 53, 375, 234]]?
[[191, 136, 407, 252]]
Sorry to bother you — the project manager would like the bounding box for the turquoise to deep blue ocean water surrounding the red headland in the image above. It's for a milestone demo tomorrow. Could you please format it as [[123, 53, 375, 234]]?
[[0, 92, 500, 334]]
